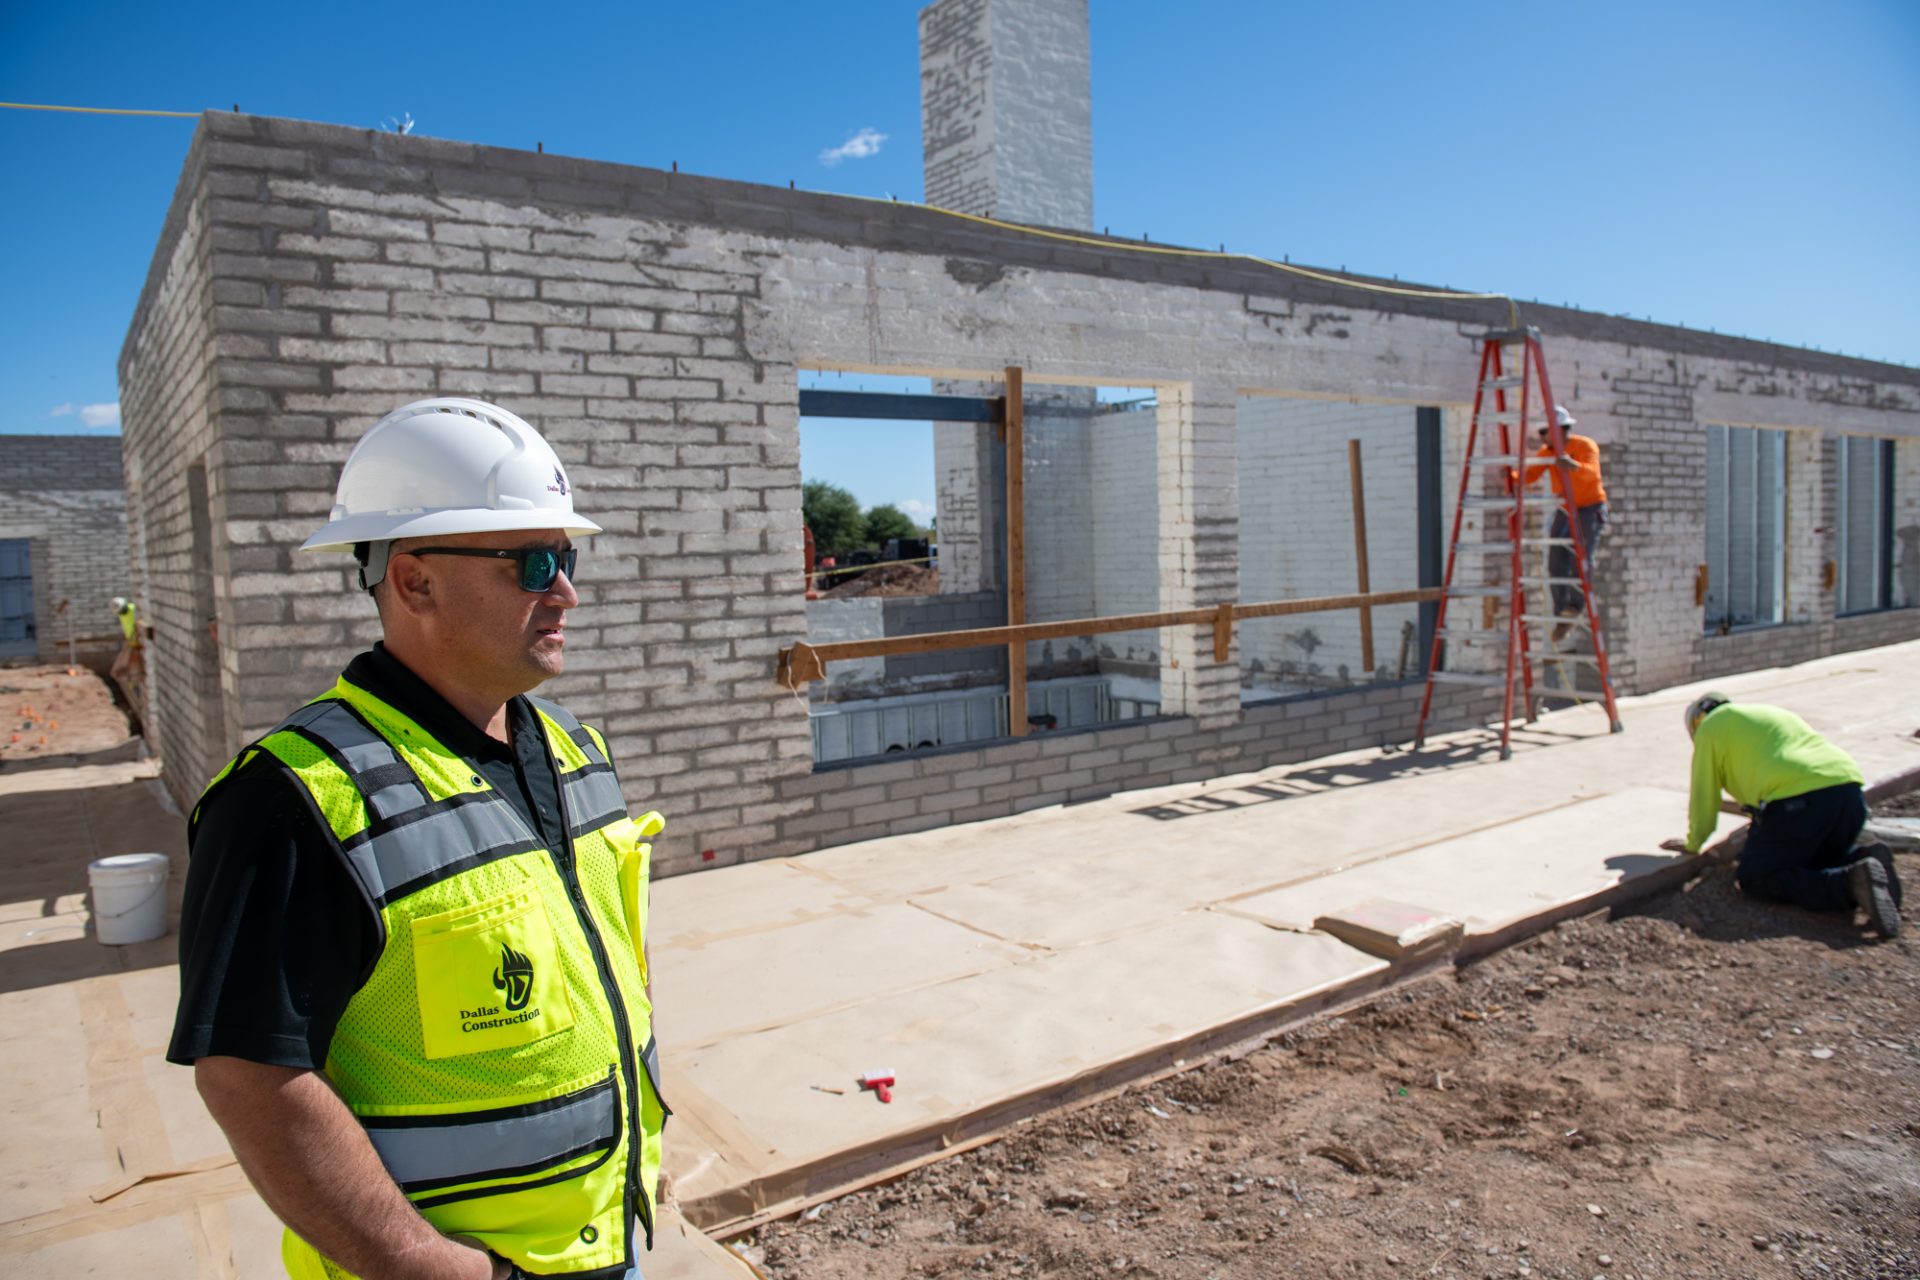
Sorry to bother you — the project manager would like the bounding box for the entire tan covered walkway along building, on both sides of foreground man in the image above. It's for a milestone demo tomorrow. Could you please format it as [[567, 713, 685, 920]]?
[[0, 643, 1920, 1280]]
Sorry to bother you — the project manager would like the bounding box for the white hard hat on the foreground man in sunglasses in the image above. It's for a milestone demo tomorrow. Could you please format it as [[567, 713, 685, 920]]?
[[300, 397, 601, 562]]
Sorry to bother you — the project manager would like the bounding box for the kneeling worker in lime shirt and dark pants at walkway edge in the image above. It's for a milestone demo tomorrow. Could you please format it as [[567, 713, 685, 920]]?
[[1661, 693, 1901, 938]]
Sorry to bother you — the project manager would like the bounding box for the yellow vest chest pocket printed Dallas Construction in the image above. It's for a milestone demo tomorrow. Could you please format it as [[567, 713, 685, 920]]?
[[411, 885, 574, 1057]]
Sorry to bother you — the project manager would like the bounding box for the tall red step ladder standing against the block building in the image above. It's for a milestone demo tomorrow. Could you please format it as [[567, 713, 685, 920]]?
[[1413, 326, 1620, 760]]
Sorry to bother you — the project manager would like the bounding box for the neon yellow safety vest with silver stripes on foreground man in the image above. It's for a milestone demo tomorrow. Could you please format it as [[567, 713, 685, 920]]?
[[194, 679, 670, 1280]]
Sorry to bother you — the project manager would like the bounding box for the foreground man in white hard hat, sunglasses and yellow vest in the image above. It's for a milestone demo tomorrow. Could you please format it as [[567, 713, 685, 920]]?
[[167, 399, 666, 1280]]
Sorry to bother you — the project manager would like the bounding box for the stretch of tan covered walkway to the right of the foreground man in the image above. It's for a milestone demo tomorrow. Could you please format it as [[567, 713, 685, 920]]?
[[653, 643, 1920, 1228]]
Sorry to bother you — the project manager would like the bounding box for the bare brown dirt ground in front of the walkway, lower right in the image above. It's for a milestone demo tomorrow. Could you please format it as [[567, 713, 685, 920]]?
[[737, 796, 1920, 1280]]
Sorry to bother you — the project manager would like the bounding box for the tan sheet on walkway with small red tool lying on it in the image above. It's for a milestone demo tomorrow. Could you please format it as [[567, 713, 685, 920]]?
[[666, 913, 1386, 1221]]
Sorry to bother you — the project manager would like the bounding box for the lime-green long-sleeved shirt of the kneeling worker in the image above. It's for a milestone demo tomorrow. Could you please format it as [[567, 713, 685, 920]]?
[[1686, 702, 1864, 854]]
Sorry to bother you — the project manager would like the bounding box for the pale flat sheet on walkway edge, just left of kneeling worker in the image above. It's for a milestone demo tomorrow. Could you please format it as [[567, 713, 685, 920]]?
[[1221, 787, 1686, 935]]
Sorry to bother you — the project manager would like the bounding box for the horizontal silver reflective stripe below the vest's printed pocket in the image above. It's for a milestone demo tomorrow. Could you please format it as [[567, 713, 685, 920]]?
[[361, 1079, 620, 1190]]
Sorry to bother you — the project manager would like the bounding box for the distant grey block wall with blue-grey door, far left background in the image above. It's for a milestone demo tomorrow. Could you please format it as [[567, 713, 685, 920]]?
[[0, 436, 134, 666]]
